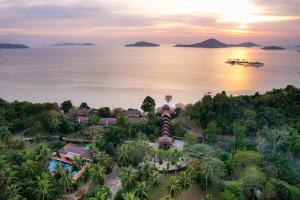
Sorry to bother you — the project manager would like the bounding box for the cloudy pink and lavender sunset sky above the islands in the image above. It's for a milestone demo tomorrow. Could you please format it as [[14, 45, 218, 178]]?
[[0, 0, 300, 45]]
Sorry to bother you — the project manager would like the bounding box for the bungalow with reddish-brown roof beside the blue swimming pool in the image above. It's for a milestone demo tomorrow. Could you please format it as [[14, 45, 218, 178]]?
[[54, 143, 91, 163]]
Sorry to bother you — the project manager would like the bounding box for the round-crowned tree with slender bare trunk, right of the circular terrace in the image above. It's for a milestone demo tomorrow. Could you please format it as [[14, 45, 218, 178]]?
[[199, 156, 225, 193]]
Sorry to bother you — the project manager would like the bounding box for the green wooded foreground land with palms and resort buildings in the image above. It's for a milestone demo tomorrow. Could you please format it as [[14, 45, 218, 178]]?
[[0, 86, 300, 200]]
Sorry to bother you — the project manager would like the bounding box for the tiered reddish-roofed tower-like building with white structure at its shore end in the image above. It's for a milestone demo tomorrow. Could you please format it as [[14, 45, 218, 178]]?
[[156, 95, 175, 148]]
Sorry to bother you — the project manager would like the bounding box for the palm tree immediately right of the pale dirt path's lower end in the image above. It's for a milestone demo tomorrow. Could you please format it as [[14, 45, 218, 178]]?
[[120, 166, 137, 190]]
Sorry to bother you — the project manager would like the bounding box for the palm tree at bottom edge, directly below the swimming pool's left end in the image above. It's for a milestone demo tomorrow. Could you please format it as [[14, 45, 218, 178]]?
[[35, 173, 55, 200]]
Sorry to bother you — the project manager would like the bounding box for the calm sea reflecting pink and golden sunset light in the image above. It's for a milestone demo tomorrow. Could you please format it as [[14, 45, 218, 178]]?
[[0, 46, 300, 108]]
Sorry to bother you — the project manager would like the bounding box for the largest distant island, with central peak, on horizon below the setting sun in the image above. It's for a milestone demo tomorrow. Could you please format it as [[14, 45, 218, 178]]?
[[175, 38, 260, 48]]
